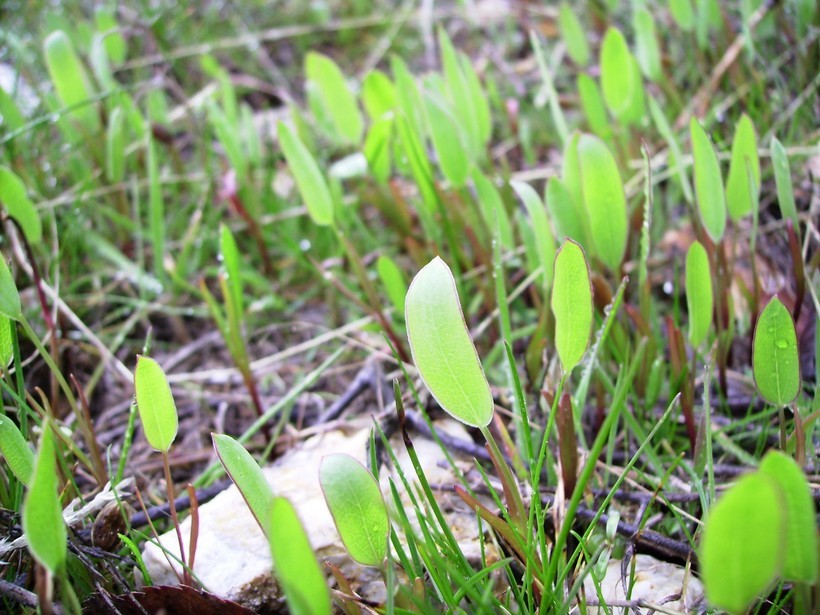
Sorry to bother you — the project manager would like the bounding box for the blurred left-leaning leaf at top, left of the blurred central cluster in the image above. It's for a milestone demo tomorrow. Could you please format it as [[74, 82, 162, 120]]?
[[305, 51, 363, 143]]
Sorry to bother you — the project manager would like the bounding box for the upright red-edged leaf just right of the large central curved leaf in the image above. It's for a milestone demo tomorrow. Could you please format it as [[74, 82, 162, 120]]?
[[550, 239, 592, 374]]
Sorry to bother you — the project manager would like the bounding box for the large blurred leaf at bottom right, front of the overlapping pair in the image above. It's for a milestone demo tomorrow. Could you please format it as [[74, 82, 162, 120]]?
[[700, 473, 784, 613]]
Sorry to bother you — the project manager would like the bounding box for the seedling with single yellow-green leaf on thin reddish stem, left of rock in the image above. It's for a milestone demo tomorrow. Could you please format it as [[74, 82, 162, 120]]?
[[134, 355, 191, 585]]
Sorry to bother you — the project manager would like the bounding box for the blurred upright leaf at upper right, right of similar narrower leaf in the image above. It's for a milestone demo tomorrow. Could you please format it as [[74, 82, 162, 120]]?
[[726, 113, 760, 221]]
